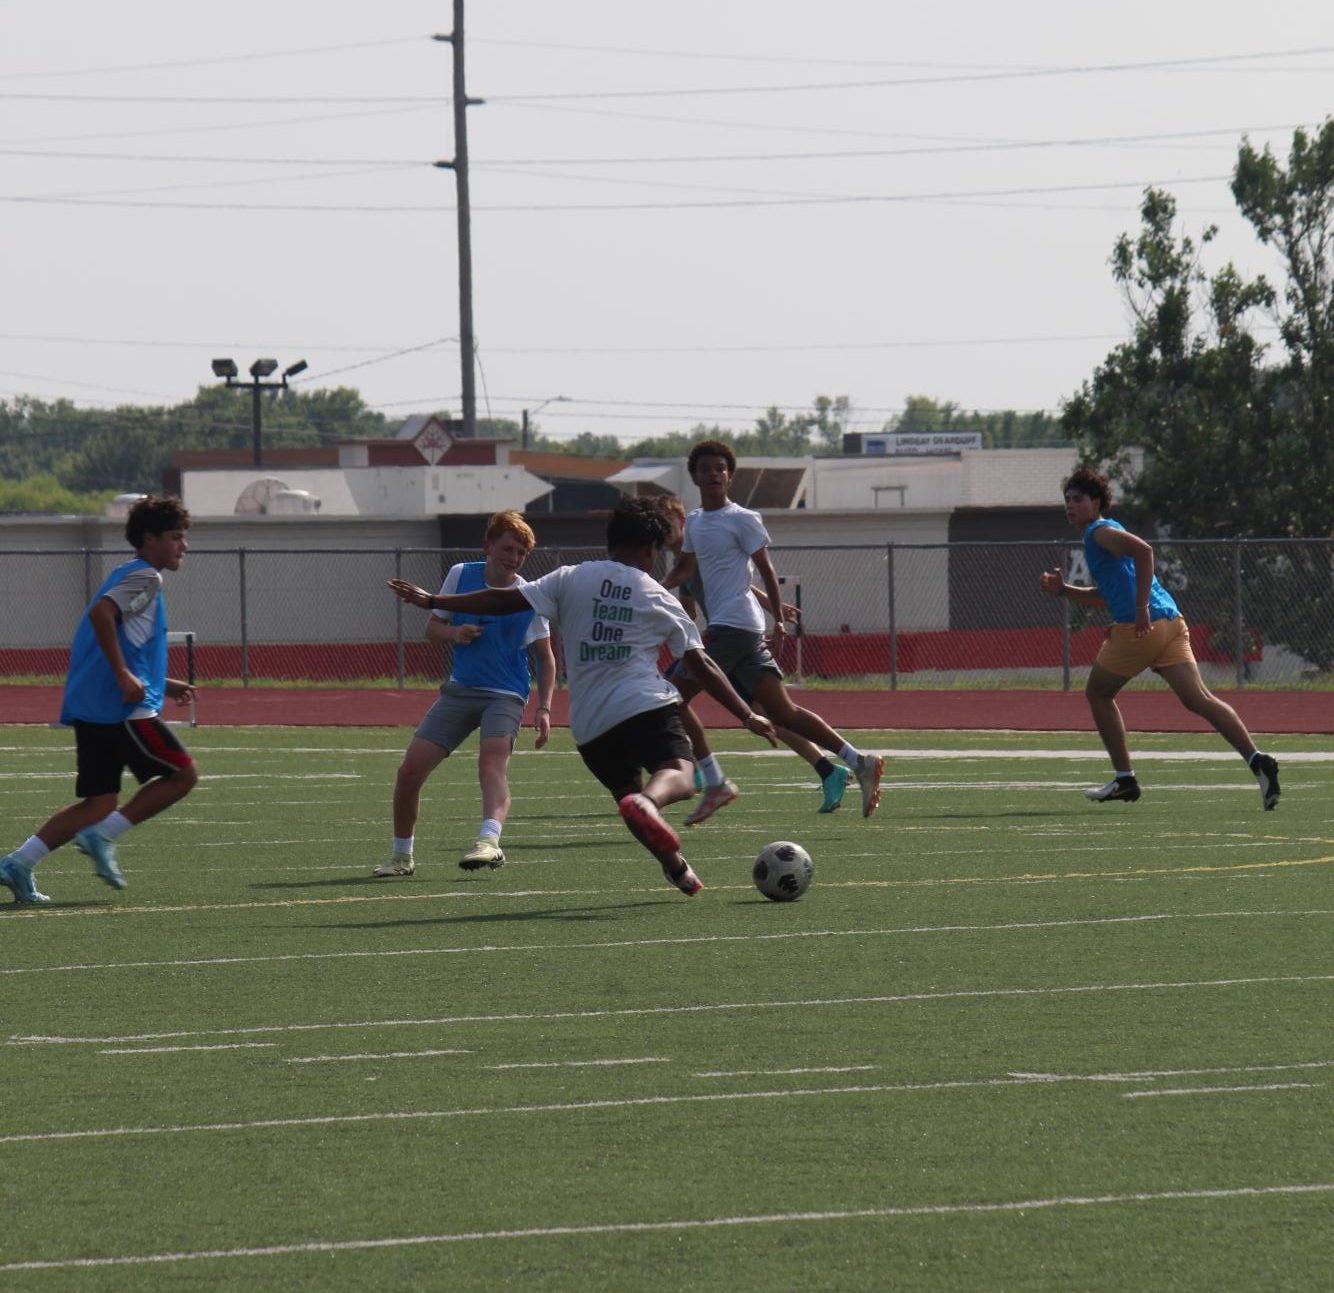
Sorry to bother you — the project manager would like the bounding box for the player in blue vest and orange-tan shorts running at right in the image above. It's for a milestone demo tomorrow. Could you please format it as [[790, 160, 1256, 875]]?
[[1039, 467, 1279, 810]]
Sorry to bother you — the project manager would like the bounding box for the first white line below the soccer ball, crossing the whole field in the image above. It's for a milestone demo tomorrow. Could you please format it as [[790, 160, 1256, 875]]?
[[0, 902, 1334, 975]]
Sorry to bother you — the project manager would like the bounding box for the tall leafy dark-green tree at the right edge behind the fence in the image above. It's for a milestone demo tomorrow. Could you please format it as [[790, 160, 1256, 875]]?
[[1062, 121, 1334, 669]]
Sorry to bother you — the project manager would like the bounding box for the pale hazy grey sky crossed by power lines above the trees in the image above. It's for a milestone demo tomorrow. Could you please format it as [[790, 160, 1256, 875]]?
[[0, 0, 1334, 440]]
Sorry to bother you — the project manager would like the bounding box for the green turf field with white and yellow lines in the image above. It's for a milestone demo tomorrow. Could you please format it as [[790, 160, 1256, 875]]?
[[0, 727, 1334, 1293]]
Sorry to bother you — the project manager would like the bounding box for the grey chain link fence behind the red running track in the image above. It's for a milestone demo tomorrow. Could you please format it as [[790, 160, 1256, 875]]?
[[0, 539, 1334, 690]]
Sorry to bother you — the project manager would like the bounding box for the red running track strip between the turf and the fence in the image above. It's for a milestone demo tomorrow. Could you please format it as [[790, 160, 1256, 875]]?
[[0, 686, 1334, 735]]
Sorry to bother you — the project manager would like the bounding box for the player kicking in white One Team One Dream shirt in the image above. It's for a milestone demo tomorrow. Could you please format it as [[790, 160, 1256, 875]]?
[[390, 499, 774, 897]]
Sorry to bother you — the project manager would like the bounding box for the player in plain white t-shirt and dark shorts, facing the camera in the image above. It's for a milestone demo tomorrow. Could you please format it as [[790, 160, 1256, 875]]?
[[663, 440, 884, 821]]
